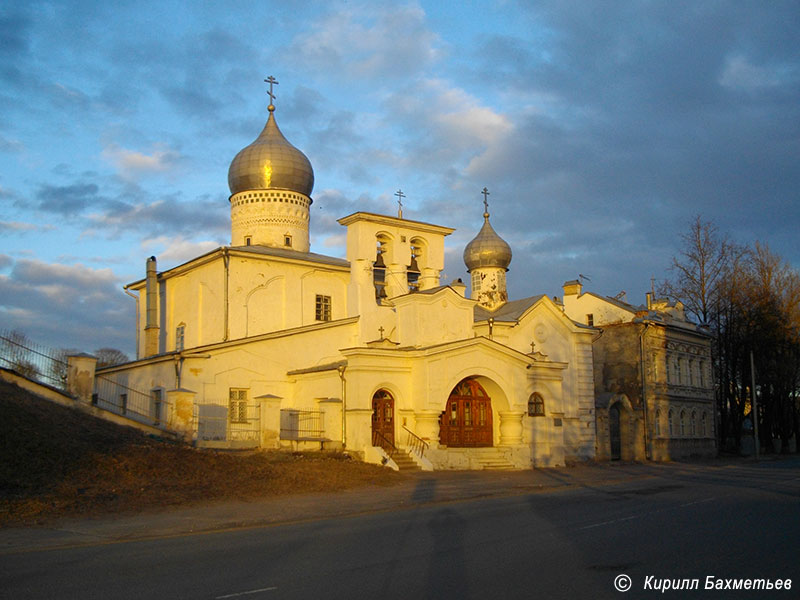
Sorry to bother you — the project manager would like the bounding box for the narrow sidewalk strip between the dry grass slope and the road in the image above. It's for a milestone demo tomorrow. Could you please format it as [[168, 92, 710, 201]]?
[[0, 463, 722, 554]]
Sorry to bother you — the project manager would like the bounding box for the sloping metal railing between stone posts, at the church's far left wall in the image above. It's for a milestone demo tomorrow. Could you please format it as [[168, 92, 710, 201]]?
[[92, 375, 171, 429]]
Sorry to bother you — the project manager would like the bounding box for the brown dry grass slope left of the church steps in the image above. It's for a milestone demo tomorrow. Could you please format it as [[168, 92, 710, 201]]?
[[0, 382, 400, 525]]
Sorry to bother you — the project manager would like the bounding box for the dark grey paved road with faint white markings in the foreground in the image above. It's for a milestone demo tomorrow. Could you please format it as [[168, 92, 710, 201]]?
[[0, 459, 800, 600]]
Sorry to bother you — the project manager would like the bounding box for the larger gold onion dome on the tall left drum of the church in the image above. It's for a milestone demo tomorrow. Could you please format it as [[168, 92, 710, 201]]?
[[228, 104, 314, 197]]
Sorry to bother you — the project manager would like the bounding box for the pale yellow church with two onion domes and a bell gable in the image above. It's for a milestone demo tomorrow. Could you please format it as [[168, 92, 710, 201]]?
[[98, 91, 598, 469]]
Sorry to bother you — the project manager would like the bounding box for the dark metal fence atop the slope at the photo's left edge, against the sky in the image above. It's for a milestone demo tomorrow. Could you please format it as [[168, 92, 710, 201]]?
[[0, 331, 68, 389]]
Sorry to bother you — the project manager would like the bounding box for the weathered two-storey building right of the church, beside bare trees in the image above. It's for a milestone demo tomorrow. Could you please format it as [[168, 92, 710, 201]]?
[[563, 281, 716, 460]]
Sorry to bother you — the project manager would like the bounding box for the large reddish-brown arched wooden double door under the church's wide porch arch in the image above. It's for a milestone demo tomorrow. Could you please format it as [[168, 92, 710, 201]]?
[[439, 378, 493, 448]]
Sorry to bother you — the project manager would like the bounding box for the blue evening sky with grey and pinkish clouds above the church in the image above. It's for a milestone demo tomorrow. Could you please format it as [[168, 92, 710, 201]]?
[[0, 0, 800, 356]]
